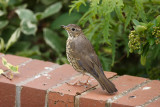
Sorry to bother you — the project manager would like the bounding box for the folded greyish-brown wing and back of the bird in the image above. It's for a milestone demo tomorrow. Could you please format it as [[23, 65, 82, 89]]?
[[71, 35, 104, 78]]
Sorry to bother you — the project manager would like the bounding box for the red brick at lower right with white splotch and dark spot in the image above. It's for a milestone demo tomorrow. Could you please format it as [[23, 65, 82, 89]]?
[[112, 80, 160, 107]]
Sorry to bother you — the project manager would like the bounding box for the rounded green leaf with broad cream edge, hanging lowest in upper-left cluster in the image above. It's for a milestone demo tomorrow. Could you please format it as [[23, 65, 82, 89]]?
[[21, 20, 37, 35]]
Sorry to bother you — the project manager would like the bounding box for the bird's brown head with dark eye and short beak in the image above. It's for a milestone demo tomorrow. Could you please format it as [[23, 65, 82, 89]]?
[[61, 24, 82, 37]]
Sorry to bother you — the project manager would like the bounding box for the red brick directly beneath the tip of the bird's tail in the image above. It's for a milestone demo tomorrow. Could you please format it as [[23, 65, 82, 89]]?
[[79, 75, 146, 107]]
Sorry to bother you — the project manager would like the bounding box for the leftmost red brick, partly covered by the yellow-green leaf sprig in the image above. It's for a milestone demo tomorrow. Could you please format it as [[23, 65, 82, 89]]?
[[0, 55, 31, 107]]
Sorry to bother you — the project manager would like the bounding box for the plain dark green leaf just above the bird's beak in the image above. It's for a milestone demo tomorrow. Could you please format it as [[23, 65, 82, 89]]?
[[51, 13, 81, 29]]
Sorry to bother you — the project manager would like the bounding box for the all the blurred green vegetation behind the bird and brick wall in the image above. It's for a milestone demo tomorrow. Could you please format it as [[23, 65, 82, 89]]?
[[0, 0, 160, 79]]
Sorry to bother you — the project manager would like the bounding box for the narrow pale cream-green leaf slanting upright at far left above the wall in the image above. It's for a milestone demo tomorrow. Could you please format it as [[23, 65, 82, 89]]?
[[6, 28, 21, 50]]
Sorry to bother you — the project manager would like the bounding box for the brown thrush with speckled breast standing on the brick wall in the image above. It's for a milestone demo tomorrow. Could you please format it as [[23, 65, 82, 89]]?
[[61, 24, 118, 94]]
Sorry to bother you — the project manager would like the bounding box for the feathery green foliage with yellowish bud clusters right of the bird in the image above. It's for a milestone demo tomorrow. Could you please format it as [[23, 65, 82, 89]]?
[[70, 0, 160, 78]]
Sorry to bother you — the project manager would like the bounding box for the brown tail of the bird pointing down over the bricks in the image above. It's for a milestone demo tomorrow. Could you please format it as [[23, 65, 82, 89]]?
[[97, 75, 118, 94]]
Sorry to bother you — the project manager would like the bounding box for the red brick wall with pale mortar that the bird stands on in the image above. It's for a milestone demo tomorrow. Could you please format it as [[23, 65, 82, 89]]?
[[0, 53, 160, 107]]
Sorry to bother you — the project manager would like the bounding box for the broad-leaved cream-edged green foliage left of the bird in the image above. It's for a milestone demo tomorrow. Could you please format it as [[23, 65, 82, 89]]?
[[0, 0, 81, 64]]
